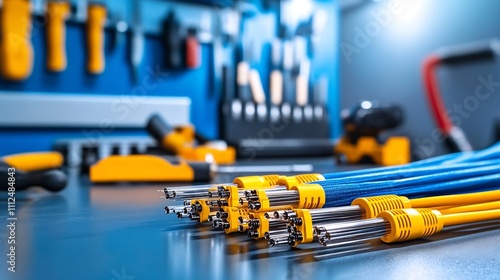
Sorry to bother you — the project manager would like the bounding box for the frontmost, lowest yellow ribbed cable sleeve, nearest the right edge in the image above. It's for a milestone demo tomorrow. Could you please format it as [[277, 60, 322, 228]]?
[[378, 208, 444, 243]]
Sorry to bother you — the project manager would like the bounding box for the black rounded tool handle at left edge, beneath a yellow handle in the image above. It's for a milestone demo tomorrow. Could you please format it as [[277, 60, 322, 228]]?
[[0, 162, 68, 192]]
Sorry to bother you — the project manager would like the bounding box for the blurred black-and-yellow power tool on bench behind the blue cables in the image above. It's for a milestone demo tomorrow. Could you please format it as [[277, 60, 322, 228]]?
[[335, 101, 410, 165]]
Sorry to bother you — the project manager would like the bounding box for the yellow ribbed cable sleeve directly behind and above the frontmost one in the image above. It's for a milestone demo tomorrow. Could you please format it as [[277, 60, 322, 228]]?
[[351, 195, 411, 219]]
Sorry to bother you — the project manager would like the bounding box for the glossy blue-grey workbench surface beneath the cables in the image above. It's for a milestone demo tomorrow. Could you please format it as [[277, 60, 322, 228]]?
[[0, 159, 500, 280]]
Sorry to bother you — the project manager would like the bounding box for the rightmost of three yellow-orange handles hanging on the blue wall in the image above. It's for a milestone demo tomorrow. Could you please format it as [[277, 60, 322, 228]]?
[[87, 4, 106, 74]]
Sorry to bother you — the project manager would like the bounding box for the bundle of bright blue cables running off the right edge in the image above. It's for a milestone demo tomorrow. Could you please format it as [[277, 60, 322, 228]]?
[[311, 143, 500, 207]]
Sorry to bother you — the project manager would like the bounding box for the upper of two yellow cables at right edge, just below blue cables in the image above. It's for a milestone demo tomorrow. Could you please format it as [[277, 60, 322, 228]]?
[[410, 190, 500, 208]]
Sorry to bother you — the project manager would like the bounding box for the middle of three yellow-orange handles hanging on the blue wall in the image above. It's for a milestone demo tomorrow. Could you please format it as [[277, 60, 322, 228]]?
[[47, 1, 71, 72]]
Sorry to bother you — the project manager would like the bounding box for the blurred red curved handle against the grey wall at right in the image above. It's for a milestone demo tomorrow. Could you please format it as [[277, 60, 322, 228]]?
[[423, 55, 453, 135]]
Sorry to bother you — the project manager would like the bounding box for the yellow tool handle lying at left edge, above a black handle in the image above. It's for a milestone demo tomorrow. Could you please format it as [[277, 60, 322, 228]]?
[[2, 152, 64, 172]]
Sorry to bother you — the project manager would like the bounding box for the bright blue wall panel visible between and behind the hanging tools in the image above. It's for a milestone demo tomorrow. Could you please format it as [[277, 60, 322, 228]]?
[[0, 1, 340, 155]]
